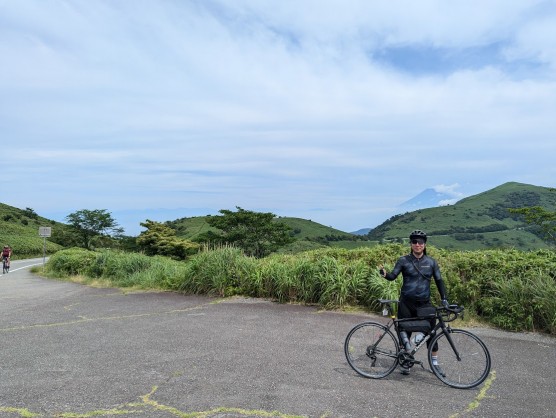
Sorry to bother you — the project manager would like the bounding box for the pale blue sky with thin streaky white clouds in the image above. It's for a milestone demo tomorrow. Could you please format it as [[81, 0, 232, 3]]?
[[0, 0, 556, 235]]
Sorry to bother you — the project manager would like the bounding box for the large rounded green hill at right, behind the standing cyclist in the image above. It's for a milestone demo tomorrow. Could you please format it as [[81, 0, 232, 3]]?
[[369, 182, 556, 250]]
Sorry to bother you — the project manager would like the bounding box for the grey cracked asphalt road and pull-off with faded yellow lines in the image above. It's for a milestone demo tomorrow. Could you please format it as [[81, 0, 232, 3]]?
[[0, 259, 556, 418]]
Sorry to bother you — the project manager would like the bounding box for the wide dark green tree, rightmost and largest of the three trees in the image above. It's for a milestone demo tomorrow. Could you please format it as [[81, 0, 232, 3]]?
[[202, 206, 295, 258]]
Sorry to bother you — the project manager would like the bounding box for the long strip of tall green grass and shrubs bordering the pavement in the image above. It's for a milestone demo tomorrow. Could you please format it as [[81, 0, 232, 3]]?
[[46, 244, 556, 335]]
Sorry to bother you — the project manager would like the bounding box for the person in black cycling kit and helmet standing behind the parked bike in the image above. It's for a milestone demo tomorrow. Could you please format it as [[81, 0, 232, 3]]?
[[379, 230, 448, 375]]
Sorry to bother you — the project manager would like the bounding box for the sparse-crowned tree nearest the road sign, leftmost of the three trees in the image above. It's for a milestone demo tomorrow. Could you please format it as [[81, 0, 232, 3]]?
[[66, 209, 124, 248]]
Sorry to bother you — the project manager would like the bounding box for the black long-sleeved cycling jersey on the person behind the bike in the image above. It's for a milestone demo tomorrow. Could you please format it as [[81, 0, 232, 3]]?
[[386, 254, 447, 302]]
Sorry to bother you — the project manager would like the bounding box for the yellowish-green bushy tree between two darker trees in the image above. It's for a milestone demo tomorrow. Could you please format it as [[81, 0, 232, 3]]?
[[137, 219, 200, 260]]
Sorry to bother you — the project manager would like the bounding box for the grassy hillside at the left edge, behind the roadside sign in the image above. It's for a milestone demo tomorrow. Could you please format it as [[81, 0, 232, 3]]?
[[0, 203, 66, 258]]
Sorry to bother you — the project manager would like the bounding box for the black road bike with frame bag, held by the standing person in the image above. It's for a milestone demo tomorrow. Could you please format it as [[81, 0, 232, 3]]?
[[344, 299, 491, 389]]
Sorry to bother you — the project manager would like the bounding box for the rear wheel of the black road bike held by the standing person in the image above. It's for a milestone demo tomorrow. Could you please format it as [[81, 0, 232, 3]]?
[[344, 322, 399, 379]]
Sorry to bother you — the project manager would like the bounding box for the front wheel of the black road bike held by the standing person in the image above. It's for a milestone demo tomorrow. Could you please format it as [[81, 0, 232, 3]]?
[[428, 329, 491, 389]]
